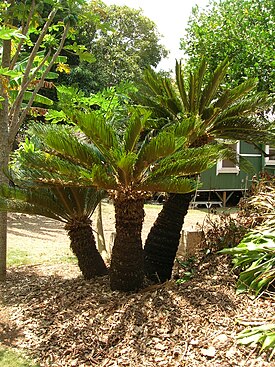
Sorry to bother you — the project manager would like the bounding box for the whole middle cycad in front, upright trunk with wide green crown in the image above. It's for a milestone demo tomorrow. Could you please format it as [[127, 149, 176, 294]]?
[[14, 108, 231, 291]]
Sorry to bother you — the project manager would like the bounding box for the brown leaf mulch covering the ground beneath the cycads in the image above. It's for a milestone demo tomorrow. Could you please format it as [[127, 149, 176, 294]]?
[[0, 255, 275, 367]]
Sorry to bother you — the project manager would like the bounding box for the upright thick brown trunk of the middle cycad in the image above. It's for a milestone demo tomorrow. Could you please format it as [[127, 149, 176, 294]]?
[[110, 194, 144, 291]]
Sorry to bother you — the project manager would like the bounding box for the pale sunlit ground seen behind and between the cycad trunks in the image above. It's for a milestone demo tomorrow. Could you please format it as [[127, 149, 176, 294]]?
[[5, 202, 209, 264]]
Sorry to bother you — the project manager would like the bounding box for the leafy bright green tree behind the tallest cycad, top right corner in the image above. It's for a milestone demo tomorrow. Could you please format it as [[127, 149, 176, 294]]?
[[181, 0, 275, 93]]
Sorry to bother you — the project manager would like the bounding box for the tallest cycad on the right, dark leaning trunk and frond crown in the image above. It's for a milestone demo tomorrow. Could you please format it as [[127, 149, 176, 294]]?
[[133, 60, 275, 281]]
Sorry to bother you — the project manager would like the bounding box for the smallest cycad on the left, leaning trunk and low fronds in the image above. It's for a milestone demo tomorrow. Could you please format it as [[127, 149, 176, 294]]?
[[0, 182, 108, 279]]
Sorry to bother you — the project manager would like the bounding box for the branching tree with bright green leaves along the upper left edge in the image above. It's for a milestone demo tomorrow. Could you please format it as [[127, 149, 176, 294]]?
[[0, 0, 83, 280]]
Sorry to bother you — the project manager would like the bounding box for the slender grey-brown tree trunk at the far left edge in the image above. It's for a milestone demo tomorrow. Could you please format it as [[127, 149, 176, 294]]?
[[0, 40, 11, 281]]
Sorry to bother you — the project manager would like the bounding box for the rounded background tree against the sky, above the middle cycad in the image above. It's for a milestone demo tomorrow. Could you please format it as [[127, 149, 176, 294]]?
[[60, 1, 167, 93]]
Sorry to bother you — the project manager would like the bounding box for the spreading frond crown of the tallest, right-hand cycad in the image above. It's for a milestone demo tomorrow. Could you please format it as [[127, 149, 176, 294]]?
[[133, 59, 274, 146]]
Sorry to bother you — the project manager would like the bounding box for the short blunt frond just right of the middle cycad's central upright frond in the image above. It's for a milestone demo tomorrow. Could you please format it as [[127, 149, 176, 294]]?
[[135, 132, 175, 175]]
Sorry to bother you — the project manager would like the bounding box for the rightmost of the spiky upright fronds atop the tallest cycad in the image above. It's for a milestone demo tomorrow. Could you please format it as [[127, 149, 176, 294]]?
[[199, 59, 229, 115]]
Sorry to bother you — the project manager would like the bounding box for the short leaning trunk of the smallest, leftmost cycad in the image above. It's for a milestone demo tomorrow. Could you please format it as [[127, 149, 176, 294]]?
[[65, 221, 108, 279]]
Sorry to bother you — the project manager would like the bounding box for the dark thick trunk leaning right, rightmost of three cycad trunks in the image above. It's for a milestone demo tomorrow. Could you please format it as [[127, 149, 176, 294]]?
[[144, 193, 191, 282]]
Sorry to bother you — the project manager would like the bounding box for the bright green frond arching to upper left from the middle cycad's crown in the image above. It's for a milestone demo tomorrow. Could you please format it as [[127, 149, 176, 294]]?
[[30, 125, 102, 168]]
